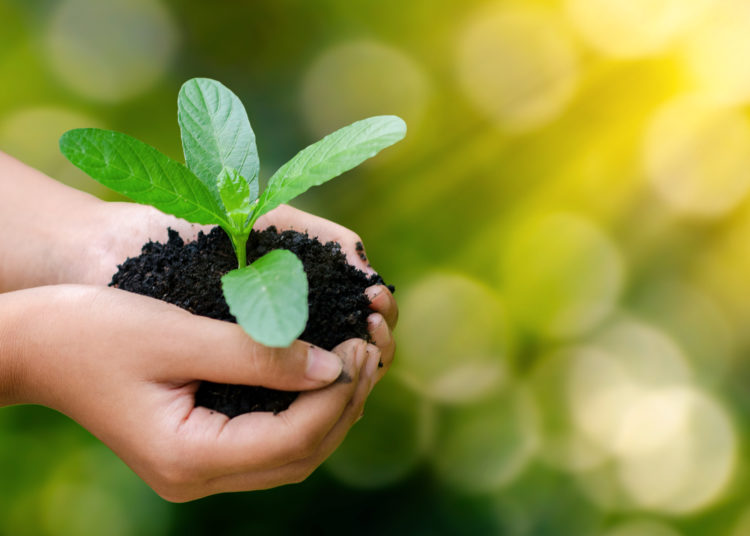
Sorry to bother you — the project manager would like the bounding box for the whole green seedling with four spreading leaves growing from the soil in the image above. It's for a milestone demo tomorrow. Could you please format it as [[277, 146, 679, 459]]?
[[60, 78, 406, 347]]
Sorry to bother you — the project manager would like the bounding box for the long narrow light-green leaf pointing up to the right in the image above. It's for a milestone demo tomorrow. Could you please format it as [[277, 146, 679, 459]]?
[[253, 115, 406, 220]]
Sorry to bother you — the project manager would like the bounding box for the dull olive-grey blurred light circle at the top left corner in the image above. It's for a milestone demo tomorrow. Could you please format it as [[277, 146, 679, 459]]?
[[46, 0, 178, 102]]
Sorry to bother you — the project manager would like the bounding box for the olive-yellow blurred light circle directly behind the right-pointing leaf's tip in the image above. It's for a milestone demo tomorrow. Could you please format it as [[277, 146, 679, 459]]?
[[301, 41, 430, 137]]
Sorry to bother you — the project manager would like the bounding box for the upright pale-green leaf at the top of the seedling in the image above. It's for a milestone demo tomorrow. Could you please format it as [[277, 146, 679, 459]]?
[[177, 78, 260, 200]]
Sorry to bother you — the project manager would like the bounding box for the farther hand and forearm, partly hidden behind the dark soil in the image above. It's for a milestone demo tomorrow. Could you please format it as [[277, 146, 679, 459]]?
[[0, 152, 398, 376]]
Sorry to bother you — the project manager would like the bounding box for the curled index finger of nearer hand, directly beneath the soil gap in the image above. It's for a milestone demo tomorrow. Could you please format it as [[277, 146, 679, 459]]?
[[185, 339, 367, 476]]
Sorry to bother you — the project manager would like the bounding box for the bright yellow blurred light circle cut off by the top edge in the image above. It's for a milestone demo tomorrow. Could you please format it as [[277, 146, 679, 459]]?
[[565, 0, 712, 58]]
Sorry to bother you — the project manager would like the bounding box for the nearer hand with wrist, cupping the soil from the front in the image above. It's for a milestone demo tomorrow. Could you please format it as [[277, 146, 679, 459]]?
[[0, 285, 380, 501]]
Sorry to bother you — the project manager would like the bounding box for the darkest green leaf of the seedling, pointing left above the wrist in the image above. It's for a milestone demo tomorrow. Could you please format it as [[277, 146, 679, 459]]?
[[60, 128, 228, 227]]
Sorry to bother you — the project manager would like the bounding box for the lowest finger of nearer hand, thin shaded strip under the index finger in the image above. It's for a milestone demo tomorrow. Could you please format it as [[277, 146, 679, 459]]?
[[200, 345, 380, 493]]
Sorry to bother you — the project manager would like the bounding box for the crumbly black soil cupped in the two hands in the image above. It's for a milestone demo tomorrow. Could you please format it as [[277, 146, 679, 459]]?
[[110, 227, 396, 417]]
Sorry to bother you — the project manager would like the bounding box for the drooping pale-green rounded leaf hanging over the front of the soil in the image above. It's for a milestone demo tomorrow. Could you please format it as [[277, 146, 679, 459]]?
[[221, 249, 308, 347]]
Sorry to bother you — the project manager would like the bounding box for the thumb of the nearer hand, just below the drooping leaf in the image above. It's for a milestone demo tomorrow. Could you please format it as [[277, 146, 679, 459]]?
[[162, 317, 343, 391]]
